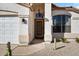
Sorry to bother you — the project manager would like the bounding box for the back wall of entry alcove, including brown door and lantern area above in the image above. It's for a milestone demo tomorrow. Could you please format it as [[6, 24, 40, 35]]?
[[34, 3, 44, 39]]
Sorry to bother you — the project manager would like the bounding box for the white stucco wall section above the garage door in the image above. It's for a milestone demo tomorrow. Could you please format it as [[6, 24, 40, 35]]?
[[0, 3, 29, 15]]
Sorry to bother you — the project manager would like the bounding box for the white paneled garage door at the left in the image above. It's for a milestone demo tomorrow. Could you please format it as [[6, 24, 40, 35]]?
[[0, 17, 19, 44]]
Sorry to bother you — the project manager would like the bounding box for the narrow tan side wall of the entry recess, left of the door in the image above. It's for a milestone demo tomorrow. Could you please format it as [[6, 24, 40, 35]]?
[[28, 10, 34, 43]]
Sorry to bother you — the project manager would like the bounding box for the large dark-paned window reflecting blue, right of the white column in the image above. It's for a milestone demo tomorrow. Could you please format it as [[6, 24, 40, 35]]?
[[53, 15, 71, 33]]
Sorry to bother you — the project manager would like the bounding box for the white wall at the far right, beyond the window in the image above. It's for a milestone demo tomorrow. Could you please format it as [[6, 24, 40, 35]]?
[[70, 12, 79, 33]]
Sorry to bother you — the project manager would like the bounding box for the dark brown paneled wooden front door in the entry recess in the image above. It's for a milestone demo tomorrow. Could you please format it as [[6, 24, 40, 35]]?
[[35, 19, 44, 38]]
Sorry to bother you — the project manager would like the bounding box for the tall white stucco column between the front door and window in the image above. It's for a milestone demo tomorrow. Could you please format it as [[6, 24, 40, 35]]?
[[44, 3, 52, 43]]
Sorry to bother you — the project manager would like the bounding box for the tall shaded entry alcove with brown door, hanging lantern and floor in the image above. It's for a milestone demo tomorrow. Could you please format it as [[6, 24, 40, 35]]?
[[31, 3, 44, 44]]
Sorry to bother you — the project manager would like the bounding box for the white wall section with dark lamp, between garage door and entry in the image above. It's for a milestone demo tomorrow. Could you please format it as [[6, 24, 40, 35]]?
[[19, 18, 29, 44]]
